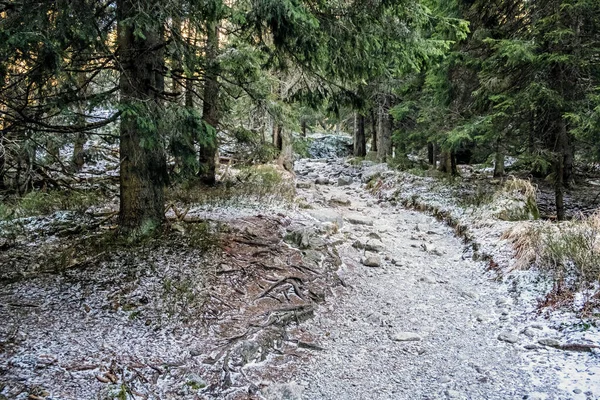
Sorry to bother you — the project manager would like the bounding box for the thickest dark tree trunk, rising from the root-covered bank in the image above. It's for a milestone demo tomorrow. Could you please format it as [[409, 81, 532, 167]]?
[[117, 0, 168, 232]]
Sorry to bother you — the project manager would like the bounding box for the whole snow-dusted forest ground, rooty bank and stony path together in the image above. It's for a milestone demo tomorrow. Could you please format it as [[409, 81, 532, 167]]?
[[0, 155, 600, 400]]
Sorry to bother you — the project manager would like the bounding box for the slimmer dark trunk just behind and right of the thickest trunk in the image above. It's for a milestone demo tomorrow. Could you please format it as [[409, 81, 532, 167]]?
[[199, 21, 219, 185]]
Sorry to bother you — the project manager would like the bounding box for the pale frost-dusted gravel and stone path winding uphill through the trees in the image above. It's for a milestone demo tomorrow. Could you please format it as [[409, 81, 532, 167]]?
[[283, 160, 598, 400]]
